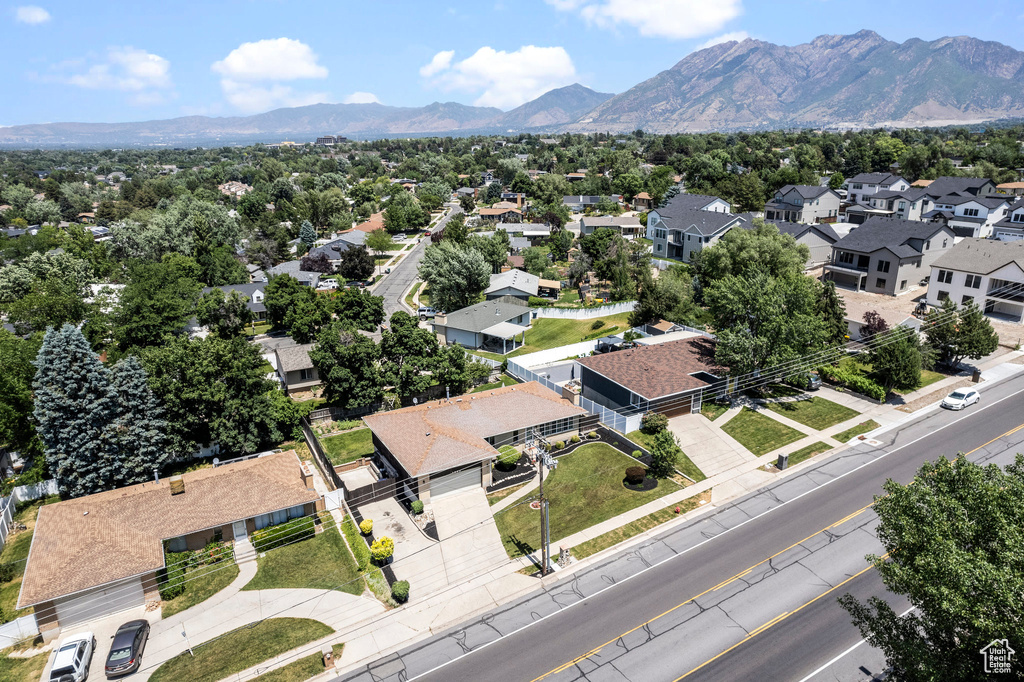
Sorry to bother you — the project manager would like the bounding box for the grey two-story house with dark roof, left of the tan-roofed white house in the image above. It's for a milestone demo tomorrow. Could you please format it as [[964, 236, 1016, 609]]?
[[822, 218, 954, 296]]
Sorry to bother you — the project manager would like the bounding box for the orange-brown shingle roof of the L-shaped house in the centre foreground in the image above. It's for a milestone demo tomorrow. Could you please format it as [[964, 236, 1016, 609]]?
[[364, 381, 586, 476]]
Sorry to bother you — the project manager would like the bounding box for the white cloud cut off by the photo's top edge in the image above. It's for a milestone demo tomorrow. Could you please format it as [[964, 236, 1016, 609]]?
[[547, 0, 743, 39]]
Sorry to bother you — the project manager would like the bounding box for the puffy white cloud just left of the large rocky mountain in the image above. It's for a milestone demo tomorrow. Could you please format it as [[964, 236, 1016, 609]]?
[[420, 45, 578, 109]]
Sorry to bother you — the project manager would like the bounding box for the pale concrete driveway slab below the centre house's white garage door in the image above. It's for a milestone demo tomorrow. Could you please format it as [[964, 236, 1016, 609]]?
[[430, 487, 509, 585]]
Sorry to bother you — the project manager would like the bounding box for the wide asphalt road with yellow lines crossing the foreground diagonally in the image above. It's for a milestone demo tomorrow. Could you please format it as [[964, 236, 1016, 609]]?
[[345, 366, 1024, 682]]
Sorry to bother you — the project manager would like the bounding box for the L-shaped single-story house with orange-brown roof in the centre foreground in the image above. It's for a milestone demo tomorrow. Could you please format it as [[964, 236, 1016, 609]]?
[[364, 381, 587, 504]]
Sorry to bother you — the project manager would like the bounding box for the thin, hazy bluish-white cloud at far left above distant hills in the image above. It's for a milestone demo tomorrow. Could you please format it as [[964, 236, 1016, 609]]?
[[62, 46, 174, 99]]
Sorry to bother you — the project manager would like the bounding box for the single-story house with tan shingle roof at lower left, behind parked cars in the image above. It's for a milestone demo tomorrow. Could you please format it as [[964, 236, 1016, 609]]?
[[17, 451, 321, 641]]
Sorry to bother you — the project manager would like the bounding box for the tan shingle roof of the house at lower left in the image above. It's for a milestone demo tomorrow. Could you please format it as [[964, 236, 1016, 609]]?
[[18, 451, 319, 608]]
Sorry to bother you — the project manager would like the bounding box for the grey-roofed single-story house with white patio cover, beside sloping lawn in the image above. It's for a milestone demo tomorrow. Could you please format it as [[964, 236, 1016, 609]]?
[[433, 294, 534, 355]]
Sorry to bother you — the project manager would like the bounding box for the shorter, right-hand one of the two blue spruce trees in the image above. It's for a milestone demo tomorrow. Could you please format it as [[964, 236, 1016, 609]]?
[[111, 355, 171, 486]]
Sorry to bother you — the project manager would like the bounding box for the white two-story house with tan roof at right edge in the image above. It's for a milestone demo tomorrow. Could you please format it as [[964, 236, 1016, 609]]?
[[928, 239, 1024, 323]]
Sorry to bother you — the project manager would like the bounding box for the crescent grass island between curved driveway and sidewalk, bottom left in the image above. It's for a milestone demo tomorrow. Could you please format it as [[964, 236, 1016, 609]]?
[[150, 619, 334, 682]]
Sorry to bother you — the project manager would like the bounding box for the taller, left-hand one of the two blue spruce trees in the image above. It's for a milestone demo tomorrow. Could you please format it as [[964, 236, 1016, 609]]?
[[33, 325, 117, 498]]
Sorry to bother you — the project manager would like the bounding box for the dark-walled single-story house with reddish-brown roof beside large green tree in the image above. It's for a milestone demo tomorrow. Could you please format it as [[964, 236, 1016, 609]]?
[[577, 336, 725, 417]]
